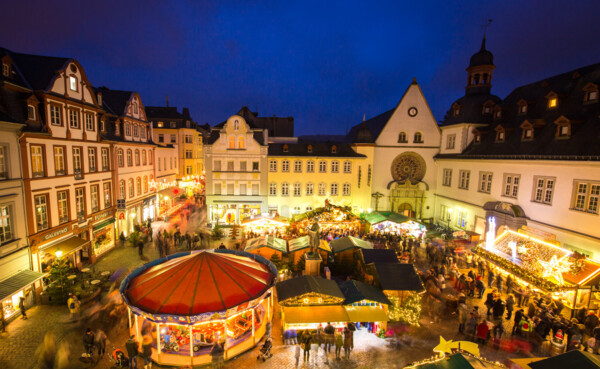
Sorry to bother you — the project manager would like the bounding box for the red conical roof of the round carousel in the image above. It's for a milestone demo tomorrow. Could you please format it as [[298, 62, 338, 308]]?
[[125, 251, 276, 315]]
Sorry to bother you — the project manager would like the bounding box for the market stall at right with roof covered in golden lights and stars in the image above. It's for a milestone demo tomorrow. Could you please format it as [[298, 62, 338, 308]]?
[[474, 230, 600, 317]]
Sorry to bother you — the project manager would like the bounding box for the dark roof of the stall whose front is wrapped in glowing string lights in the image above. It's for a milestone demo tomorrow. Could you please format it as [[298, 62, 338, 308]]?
[[373, 263, 425, 291]]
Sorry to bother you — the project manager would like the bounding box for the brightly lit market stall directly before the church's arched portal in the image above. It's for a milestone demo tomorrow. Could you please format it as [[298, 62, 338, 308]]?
[[364, 211, 427, 238]]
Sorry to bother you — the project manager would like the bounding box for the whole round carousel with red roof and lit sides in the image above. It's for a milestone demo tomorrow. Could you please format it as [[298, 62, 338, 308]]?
[[120, 250, 277, 366]]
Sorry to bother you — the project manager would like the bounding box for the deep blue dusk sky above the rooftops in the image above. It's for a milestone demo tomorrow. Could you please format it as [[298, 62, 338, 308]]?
[[0, 0, 600, 135]]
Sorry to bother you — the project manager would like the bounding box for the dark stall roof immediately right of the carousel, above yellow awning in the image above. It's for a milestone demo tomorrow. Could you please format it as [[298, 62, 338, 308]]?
[[275, 276, 344, 302]]
